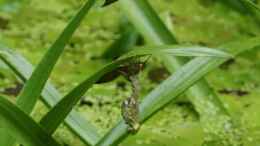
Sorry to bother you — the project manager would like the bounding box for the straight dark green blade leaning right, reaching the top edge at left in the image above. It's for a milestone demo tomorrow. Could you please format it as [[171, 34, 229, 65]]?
[[0, 0, 95, 146]]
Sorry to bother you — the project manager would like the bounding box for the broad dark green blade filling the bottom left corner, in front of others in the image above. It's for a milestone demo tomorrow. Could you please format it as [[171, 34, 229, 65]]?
[[0, 97, 59, 146]]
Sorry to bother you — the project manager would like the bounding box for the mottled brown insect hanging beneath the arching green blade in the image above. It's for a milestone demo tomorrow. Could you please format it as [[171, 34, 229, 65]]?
[[98, 57, 150, 133]]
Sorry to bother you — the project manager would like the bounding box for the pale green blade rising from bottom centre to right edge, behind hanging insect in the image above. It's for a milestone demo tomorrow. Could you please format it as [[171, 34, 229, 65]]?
[[96, 37, 260, 146]]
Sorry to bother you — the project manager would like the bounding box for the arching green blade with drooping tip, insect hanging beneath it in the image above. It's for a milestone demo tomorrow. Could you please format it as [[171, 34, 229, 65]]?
[[40, 46, 230, 133]]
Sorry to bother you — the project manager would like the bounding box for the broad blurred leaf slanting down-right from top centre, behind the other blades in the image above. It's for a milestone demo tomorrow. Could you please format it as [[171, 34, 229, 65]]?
[[119, 0, 233, 138]]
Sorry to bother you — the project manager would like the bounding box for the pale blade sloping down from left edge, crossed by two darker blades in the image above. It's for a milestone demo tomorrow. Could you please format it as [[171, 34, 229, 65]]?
[[0, 47, 100, 145]]
